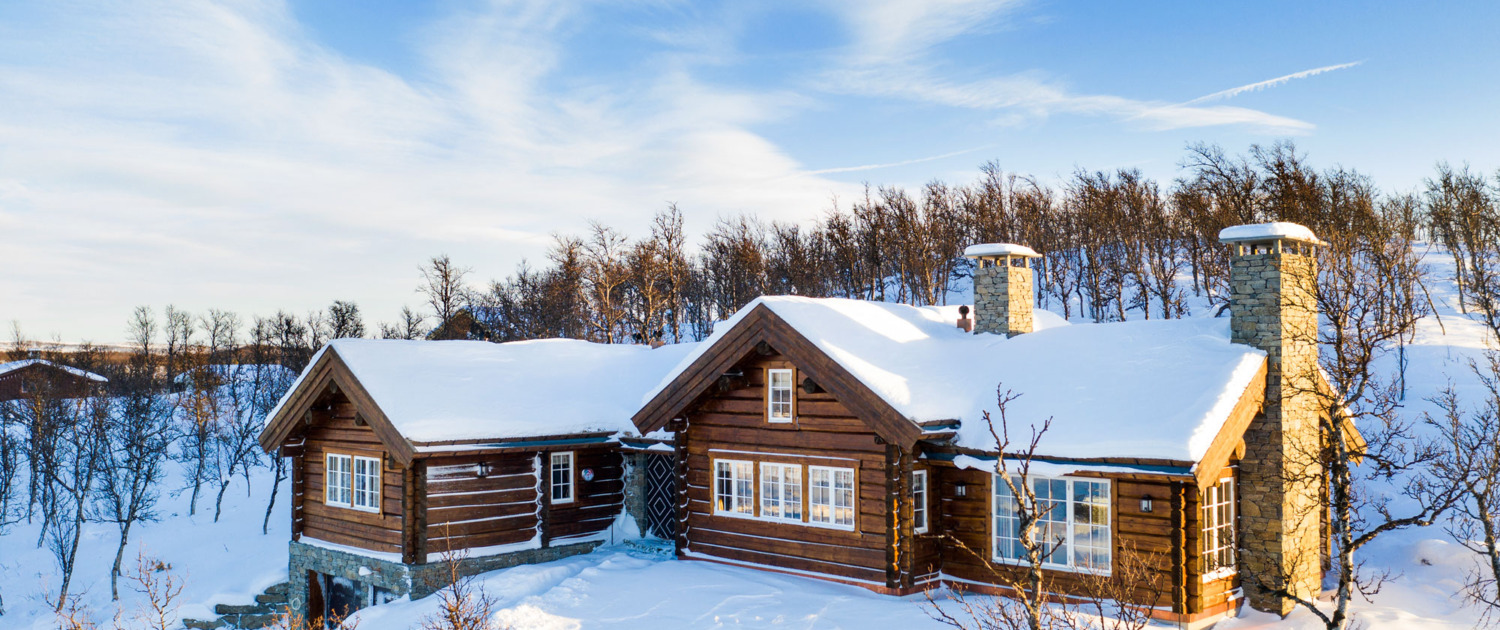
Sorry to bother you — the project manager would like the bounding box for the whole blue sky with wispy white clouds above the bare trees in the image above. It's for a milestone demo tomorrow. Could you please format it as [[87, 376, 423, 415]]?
[[0, 0, 1500, 342]]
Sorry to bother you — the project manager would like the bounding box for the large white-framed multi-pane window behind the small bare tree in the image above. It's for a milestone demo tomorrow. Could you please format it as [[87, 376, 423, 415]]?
[[993, 476, 1113, 573]]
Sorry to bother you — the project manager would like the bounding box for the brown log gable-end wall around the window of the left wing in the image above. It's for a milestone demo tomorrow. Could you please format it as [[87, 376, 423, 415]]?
[[293, 402, 404, 554]]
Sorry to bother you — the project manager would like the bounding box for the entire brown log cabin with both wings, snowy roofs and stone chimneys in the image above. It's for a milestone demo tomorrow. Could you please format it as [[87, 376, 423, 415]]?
[[261, 224, 1361, 627]]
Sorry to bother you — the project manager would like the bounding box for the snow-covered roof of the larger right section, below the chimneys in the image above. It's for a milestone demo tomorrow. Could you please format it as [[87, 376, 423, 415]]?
[[642, 296, 1266, 462]]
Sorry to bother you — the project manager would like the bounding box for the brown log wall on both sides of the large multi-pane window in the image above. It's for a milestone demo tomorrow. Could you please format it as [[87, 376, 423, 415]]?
[[933, 467, 1197, 608]]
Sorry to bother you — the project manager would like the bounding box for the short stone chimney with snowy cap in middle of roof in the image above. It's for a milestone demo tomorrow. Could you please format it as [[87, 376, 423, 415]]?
[[963, 243, 1041, 338]]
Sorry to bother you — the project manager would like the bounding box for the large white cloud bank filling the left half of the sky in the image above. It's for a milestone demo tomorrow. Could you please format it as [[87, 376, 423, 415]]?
[[0, 0, 852, 341]]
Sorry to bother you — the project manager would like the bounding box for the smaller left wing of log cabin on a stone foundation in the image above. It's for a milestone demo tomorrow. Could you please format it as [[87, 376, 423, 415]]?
[[260, 339, 692, 618]]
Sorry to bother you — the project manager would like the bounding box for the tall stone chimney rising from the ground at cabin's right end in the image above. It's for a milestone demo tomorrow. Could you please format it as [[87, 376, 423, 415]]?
[[1220, 224, 1323, 615]]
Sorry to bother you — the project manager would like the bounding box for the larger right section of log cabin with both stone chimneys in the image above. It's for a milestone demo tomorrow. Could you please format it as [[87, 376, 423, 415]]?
[[633, 224, 1359, 627]]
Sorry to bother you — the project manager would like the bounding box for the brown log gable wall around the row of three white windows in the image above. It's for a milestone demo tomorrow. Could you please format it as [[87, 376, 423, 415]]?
[[683, 354, 893, 585]]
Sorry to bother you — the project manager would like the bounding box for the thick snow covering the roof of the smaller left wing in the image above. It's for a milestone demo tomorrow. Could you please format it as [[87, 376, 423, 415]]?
[[280, 339, 695, 443]]
